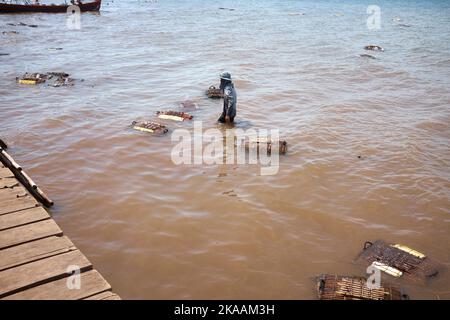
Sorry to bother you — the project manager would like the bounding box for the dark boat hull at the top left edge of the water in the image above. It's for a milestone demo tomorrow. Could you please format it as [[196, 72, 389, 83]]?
[[0, 0, 102, 14]]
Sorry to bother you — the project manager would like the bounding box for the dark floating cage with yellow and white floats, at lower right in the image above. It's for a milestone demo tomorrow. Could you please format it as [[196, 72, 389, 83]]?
[[356, 240, 439, 281]]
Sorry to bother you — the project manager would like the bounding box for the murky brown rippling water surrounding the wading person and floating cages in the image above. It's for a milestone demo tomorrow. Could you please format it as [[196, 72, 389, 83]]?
[[0, 1, 450, 299]]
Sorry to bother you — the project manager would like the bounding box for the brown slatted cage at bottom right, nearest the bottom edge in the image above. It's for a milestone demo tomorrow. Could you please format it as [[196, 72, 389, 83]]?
[[317, 274, 409, 300]]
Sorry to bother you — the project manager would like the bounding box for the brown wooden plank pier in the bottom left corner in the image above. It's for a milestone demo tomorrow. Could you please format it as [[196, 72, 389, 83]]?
[[0, 147, 120, 300]]
